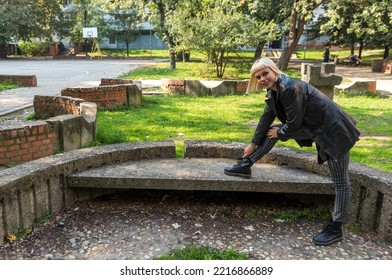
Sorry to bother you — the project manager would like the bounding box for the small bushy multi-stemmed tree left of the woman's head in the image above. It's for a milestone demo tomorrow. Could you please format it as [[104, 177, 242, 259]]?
[[167, 0, 275, 78]]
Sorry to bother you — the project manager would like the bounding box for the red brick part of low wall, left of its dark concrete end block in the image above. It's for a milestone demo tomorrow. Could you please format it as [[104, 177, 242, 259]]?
[[61, 85, 127, 109]]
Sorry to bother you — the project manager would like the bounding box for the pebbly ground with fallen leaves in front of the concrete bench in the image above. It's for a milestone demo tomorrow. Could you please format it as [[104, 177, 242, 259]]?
[[0, 191, 392, 260]]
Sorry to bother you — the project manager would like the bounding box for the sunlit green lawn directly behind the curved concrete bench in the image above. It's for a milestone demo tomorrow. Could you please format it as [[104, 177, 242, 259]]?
[[97, 93, 392, 172]]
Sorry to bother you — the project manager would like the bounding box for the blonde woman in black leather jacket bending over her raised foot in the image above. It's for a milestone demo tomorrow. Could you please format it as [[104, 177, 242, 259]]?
[[224, 57, 360, 245]]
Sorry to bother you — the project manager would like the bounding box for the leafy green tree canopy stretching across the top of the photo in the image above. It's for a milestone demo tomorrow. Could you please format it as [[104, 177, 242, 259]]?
[[0, 0, 392, 67]]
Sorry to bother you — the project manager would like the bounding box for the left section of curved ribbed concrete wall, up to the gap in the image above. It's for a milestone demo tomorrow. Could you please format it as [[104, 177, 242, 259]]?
[[0, 141, 176, 244]]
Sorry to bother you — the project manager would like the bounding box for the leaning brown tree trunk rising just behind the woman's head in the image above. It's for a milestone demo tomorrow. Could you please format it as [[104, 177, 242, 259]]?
[[277, 5, 305, 71]]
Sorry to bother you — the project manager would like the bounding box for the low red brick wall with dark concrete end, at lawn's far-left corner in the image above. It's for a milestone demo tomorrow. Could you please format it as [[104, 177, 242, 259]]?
[[61, 84, 142, 109]]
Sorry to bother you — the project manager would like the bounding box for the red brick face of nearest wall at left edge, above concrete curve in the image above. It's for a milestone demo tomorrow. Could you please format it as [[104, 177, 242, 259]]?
[[0, 121, 56, 165]]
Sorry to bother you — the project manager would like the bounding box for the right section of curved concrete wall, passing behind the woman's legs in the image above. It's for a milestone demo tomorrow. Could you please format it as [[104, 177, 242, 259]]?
[[185, 141, 392, 241]]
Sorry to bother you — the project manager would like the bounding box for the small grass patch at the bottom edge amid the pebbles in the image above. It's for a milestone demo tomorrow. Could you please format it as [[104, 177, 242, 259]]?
[[156, 246, 247, 260]]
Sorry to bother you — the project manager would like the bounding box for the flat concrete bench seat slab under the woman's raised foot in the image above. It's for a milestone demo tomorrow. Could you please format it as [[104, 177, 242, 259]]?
[[67, 158, 334, 195]]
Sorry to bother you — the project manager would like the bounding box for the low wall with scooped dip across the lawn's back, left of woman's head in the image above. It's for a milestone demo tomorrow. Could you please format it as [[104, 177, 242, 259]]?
[[161, 79, 248, 96]]
